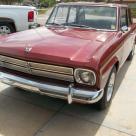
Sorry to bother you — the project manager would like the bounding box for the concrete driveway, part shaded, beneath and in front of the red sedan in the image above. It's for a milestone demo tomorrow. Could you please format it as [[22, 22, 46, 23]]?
[[0, 51, 136, 136]]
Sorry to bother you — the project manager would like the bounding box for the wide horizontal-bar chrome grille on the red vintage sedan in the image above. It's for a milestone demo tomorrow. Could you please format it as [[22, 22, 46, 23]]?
[[0, 55, 74, 82]]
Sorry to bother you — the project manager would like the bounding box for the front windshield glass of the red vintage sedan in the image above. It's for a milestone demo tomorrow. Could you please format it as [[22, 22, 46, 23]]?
[[46, 6, 116, 30]]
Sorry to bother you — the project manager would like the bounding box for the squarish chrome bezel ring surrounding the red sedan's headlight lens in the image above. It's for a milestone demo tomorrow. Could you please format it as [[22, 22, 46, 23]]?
[[74, 68, 96, 86]]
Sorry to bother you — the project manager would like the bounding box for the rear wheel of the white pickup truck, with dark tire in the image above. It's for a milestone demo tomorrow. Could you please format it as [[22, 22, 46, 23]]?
[[0, 23, 16, 34]]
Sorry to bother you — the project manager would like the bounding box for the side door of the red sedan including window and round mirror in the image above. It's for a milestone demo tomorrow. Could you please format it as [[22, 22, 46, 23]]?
[[120, 7, 134, 63]]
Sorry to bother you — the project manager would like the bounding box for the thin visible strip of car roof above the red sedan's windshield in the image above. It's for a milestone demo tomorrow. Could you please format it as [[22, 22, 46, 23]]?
[[57, 2, 127, 7]]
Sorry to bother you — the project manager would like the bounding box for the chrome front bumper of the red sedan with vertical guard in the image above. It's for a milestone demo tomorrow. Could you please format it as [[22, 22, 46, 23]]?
[[0, 72, 104, 104]]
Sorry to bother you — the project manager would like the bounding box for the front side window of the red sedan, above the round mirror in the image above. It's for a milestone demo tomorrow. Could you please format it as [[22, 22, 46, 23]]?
[[120, 8, 128, 28]]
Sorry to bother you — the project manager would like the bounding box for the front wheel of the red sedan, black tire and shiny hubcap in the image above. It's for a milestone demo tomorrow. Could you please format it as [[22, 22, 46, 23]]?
[[97, 66, 116, 110]]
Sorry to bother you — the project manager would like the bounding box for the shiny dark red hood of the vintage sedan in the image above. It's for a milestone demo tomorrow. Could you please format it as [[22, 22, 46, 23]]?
[[0, 27, 115, 66]]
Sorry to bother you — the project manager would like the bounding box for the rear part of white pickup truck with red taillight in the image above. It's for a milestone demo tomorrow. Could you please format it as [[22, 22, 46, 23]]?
[[0, 5, 37, 34]]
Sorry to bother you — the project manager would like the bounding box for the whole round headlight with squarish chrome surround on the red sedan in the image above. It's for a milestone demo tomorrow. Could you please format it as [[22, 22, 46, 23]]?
[[74, 68, 96, 86]]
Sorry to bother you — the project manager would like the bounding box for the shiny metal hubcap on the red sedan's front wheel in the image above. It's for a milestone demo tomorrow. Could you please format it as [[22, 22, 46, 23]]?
[[107, 73, 115, 102]]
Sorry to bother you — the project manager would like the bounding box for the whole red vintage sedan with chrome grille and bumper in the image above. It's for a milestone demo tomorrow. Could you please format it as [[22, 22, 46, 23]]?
[[0, 2, 136, 109]]
